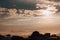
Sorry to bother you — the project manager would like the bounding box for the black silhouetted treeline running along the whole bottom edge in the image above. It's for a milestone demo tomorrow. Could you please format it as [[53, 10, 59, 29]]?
[[0, 31, 60, 40]]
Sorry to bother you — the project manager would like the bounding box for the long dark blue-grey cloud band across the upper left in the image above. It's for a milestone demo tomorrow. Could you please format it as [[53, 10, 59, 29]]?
[[0, 0, 36, 10]]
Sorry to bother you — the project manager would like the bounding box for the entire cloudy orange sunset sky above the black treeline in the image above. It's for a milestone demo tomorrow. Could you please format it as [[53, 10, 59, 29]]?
[[0, 0, 60, 35]]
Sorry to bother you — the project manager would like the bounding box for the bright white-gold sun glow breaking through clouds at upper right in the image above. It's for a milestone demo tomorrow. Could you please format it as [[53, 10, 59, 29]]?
[[42, 6, 57, 16]]
